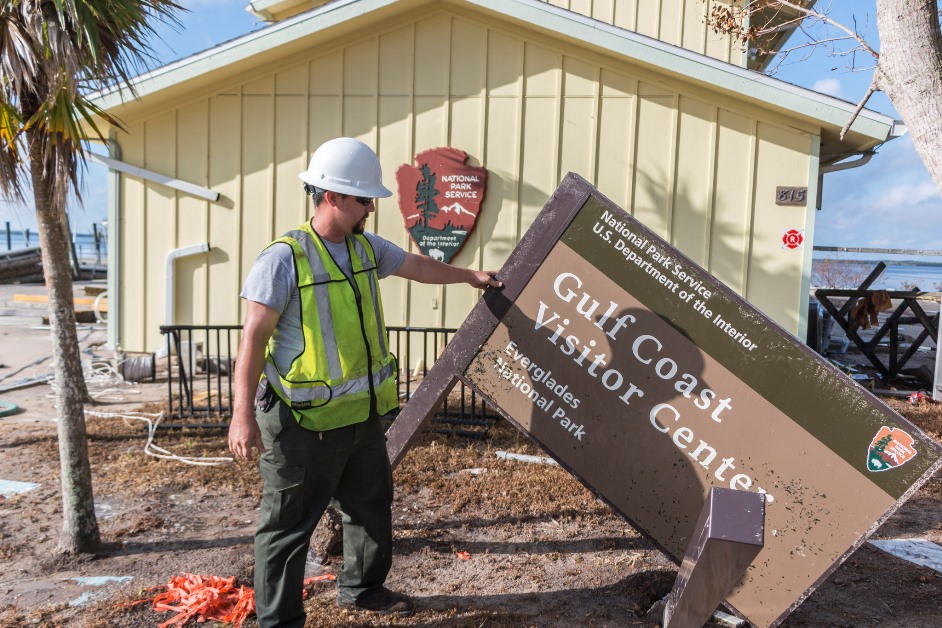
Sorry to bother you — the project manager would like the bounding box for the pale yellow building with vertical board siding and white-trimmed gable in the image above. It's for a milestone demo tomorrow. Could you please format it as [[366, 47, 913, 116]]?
[[97, 0, 901, 351]]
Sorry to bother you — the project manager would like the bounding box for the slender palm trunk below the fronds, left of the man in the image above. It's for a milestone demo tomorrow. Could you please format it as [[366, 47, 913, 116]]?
[[27, 131, 101, 553]]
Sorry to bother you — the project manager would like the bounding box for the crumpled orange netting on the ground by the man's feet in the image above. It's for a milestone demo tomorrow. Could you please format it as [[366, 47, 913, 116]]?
[[131, 573, 337, 628]]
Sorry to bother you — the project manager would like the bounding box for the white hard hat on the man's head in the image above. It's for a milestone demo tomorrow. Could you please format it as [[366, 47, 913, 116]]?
[[298, 137, 392, 198]]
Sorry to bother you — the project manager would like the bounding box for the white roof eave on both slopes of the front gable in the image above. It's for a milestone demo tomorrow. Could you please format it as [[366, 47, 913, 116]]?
[[95, 0, 898, 152]]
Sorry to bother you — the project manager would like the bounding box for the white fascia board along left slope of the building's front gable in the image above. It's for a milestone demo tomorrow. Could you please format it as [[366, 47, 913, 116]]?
[[90, 0, 397, 111]]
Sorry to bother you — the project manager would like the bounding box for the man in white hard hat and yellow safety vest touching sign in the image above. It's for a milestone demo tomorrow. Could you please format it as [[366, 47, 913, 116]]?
[[229, 138, 502, 628]]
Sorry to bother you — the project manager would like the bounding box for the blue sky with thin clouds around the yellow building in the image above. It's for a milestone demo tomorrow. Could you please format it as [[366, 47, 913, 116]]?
[[0, 0, 942, 259]]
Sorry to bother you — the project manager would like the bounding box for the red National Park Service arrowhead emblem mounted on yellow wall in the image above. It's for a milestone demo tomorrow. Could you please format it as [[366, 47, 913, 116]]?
[[396, 148, 487, 263]]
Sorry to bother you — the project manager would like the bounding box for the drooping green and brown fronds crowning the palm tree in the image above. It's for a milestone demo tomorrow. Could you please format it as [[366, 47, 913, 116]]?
[[0, 0, 185, 203]]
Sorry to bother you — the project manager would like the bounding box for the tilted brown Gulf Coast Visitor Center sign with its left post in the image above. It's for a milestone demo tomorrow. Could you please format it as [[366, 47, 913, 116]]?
[[388, 174, 942, 626]]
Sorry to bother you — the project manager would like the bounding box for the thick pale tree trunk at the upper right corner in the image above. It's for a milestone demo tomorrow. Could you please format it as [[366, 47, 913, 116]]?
[[874, 0, 942, 193]]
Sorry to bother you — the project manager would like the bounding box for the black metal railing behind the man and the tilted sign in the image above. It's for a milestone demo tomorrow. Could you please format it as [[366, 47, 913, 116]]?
[[160, 325, 497, 435]]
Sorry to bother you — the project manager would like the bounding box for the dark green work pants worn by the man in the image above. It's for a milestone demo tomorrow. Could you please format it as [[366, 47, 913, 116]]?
[[255, 401, 393, 628]]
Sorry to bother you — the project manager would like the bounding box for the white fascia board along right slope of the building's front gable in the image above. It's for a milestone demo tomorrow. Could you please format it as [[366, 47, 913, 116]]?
[[463, 0, 899, 141]]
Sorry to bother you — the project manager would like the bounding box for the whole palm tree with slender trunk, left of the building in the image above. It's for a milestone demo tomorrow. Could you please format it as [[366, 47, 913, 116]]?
[[0, 0, 182, 553]]
